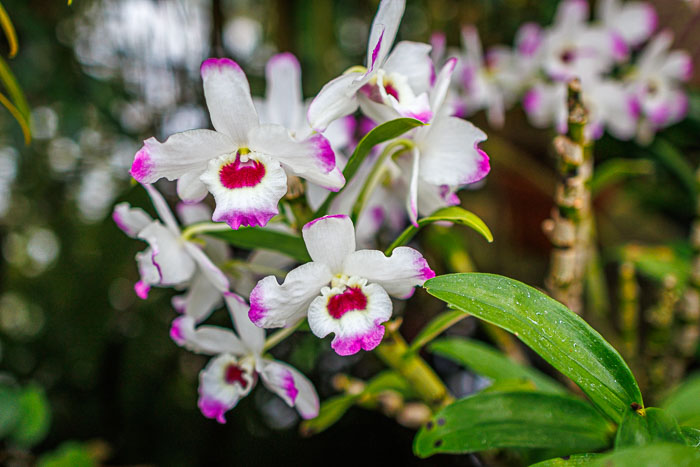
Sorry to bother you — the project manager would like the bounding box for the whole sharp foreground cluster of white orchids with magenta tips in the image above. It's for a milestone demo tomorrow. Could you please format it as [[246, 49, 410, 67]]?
[[113, 0, 489, 423]]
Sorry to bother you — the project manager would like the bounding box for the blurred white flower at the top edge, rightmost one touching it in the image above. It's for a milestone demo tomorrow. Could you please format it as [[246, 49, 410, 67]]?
[[596, 0, 658, 47]]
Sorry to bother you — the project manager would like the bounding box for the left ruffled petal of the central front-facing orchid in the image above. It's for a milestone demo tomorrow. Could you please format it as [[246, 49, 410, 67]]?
[[248, 263, 332, 328]]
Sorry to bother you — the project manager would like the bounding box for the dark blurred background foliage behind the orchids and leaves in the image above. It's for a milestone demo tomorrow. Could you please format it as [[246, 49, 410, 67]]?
[[0, 0, 700, 466]]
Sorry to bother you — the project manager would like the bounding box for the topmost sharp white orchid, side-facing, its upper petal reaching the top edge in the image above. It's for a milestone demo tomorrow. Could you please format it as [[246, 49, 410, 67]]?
[[308, 0, 433, 131]]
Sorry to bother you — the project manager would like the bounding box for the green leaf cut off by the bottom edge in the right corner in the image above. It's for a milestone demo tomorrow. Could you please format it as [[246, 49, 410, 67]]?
[[589, 444, 700, 467]]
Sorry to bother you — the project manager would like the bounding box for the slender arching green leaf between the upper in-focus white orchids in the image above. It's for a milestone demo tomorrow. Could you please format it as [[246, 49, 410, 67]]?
[[313, 118, 424, 219]]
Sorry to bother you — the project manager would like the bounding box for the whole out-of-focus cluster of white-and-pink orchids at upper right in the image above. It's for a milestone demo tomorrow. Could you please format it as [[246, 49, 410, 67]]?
[[452, 0, 692, 143]]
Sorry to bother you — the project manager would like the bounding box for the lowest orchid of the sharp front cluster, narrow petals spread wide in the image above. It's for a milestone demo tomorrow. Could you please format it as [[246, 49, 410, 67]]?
[[170, 293, 319, 423]]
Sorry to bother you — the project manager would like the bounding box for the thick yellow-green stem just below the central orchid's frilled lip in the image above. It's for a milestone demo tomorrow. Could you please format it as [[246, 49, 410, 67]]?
[[375, 325, 454, 410]]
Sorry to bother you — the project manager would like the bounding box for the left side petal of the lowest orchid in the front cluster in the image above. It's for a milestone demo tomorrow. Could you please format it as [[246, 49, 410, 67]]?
[[170, 315, 248, 355]]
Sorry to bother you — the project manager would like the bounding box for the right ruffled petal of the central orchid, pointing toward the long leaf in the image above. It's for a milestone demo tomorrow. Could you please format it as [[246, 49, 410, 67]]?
[[343, 246, 435, 298]]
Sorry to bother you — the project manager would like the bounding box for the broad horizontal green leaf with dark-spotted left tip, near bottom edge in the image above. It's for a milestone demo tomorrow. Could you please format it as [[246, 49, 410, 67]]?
[[413, 392, 611, 457]]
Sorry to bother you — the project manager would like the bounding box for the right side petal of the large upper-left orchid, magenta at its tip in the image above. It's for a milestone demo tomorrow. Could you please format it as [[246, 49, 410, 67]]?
[[250, 125, 345, 191]]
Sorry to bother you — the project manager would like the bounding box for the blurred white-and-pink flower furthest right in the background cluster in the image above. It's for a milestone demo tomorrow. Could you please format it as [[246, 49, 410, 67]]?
[[627, 31, 693, 140]]
